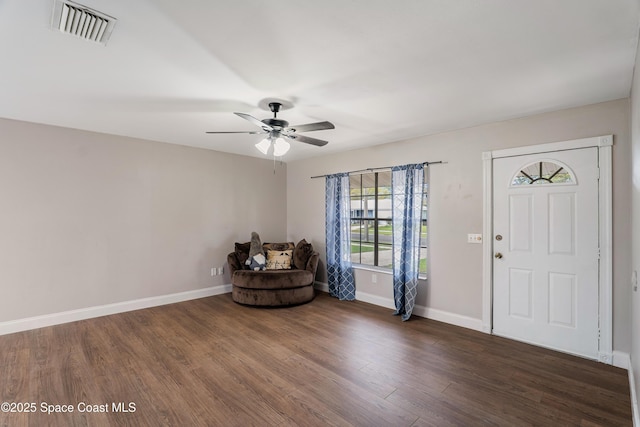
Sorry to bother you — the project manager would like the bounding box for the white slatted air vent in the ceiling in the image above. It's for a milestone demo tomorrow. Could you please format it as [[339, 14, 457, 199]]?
[[51, 0, 117, 45]]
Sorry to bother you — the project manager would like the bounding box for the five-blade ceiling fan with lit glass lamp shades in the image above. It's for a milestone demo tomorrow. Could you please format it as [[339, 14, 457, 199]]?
[[207, 102, 335, 156]]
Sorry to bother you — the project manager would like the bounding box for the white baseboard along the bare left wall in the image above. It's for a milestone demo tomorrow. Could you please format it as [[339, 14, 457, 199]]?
[[0, 285, 231, 335]]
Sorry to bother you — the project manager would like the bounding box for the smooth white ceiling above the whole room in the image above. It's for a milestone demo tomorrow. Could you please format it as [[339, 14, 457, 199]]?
[[0, 0, 640, 161]]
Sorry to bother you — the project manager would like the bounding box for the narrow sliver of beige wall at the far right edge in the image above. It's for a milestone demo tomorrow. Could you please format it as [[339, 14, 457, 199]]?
[[630, 34, 640, 422]]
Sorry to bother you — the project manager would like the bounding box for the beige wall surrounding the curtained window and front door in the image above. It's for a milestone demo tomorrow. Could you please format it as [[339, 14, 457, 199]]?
[[287, 99, 631, 352]]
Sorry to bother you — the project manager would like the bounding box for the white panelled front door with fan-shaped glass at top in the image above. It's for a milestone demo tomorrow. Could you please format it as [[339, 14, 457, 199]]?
[[491, 148, 599, 359]]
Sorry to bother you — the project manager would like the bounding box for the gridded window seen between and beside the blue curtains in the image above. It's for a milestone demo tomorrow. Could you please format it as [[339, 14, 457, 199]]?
[[349, 168, 427, 274]]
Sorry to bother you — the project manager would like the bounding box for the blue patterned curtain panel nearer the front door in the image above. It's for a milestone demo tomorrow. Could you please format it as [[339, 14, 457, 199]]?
[[391, 163, 424, 320]]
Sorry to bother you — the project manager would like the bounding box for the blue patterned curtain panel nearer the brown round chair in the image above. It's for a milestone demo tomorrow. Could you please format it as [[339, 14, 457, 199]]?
[[325, 173, 356, 301]]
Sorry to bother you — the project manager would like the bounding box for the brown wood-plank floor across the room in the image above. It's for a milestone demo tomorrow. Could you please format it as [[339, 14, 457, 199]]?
[[0, 294, 632, 427]]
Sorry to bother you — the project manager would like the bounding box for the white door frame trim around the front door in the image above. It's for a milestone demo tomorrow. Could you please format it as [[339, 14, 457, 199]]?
[[482, 135, 613, 365]]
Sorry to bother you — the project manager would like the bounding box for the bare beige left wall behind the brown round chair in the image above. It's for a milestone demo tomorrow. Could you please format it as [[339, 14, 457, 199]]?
[[0, 119, 287, 322]]
